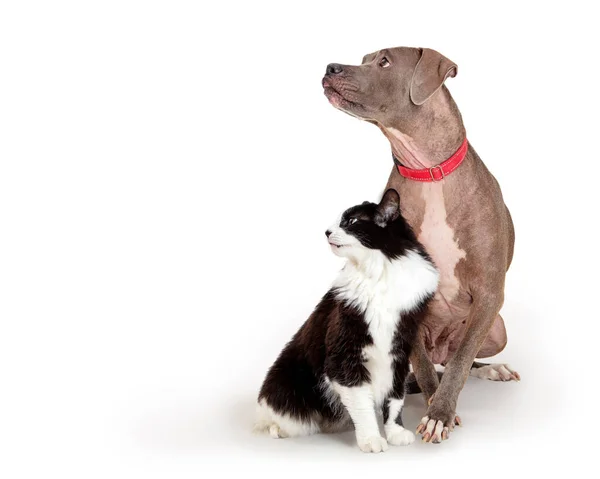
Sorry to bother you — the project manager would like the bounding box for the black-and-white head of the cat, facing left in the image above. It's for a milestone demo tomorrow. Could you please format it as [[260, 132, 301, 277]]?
[[325, 189, 420, 262]]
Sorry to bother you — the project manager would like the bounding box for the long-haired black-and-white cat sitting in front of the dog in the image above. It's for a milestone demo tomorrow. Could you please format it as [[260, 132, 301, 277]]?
[[255, 190, 439, 452]]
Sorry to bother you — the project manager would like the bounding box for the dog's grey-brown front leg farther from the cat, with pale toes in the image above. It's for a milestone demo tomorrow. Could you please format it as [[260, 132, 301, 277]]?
[[417, 285, 504, 442]]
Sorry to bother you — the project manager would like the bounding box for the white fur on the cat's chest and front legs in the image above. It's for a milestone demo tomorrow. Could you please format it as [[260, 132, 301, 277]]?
[[330, 249, 438, 451]]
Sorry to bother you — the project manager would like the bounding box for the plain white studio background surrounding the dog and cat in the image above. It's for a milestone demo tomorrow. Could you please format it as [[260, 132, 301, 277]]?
[[0, 1, 600, 478]]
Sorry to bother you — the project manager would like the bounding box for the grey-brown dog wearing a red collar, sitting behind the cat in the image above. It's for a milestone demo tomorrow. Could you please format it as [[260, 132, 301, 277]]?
[[322, 47, 520, 442]]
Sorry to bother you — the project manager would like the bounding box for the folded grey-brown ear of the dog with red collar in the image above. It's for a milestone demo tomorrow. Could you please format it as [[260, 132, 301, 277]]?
[[410, 48, 458, 105]]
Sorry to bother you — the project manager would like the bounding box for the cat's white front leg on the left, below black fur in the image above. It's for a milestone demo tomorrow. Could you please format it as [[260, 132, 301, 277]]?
[[332, 382, 388, 453]]
